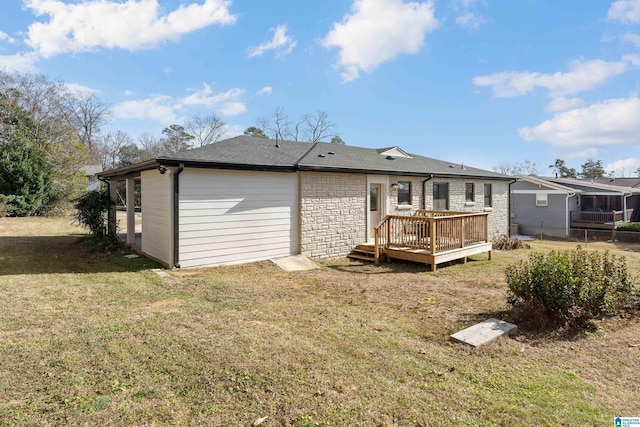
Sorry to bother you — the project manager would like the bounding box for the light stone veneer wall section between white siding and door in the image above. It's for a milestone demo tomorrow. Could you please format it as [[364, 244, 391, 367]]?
[[299, 172, 367, 258]]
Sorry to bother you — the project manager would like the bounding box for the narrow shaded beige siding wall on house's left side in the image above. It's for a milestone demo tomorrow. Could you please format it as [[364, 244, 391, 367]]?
[[141, 170, 173, 265]]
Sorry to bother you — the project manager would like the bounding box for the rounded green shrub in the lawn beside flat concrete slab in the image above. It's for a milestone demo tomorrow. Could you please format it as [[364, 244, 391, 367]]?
[[506, 246, 634, 327]]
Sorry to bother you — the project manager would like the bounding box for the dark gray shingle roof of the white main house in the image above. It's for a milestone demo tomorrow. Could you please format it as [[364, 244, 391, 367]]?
[[102, 135, 512, 180]]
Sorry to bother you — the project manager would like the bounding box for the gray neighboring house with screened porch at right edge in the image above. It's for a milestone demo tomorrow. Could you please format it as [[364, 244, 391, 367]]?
[[511, 176, 640, 237]]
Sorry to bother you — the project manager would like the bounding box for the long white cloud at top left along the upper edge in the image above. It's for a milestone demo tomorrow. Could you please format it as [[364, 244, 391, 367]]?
[[24, 0, 236, 57]]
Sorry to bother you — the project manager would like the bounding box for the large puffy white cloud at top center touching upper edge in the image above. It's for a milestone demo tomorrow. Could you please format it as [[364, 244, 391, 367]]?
[[322, 0, 439, 82]]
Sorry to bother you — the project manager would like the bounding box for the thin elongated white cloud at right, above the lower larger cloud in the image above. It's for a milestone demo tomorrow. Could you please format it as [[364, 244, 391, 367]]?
[[473, 55, 638, 98]]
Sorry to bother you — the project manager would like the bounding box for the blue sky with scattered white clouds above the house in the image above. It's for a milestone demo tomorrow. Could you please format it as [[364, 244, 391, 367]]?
[[0, 0, 640, 176]]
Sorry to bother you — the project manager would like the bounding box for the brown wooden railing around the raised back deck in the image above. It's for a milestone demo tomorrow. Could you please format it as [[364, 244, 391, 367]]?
[[374, 210, 489, 261]]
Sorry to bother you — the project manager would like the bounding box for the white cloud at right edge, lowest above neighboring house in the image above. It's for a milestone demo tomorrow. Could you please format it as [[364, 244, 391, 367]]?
[[518, 97, 640, 147]]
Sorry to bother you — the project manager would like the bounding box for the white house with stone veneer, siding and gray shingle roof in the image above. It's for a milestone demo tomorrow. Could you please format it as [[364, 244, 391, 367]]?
[[99, 136, 511, 268]]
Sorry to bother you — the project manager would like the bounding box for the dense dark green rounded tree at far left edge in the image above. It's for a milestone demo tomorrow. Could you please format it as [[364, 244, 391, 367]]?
[[0, 135, 53, 216]]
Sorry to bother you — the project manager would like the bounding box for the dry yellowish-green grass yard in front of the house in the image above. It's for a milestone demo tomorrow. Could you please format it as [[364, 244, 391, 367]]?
[[0, 218, 640, 427]]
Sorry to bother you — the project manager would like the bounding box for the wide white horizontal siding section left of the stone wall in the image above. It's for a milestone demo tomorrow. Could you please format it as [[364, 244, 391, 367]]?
[[179, 169, 298, 268]]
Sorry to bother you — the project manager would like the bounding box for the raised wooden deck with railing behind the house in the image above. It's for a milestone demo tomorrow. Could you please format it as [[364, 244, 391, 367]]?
[[368, 210, 492, 271]]
